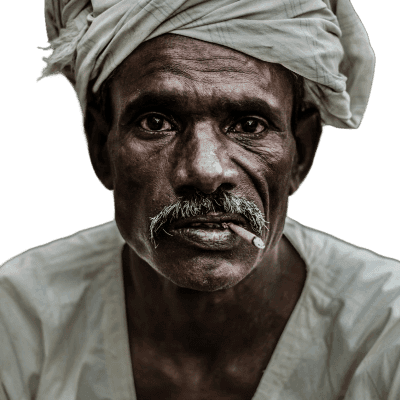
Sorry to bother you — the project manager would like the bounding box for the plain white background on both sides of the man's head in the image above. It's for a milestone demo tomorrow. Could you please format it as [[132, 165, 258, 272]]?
[[0, 0, 400, 262]]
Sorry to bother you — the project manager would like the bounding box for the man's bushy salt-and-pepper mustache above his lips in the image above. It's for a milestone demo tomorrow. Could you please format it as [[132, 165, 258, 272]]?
[[149, 189, 269, 245]]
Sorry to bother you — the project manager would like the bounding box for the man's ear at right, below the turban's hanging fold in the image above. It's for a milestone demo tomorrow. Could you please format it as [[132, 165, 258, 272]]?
[[289, 108, 323, 196]]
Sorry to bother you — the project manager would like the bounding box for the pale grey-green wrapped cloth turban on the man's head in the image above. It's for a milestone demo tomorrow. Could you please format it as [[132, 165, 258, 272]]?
[[41, 0, 375, 129]]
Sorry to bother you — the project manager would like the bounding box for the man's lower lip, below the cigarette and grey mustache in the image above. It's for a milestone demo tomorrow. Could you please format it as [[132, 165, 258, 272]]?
[[169, 227, 240, 250]]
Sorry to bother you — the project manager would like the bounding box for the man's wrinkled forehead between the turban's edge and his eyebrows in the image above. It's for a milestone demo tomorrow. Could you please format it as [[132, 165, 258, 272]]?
[[111, 34, 293, 123]]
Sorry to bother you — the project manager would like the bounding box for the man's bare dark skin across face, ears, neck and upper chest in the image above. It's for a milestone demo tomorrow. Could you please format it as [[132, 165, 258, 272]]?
[[86, 35, 321, 400]]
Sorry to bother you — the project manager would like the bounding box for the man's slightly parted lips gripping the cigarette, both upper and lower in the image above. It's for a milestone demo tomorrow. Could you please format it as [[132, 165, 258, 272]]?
[[161, 213, 247, 250]]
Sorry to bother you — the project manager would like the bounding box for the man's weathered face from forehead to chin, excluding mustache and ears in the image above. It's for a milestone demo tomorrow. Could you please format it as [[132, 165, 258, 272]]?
[[107, 35, 296, 291]]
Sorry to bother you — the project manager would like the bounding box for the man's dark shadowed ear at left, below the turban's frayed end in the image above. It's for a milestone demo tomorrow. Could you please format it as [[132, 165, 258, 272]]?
[[84, 105, 113, 191]]
